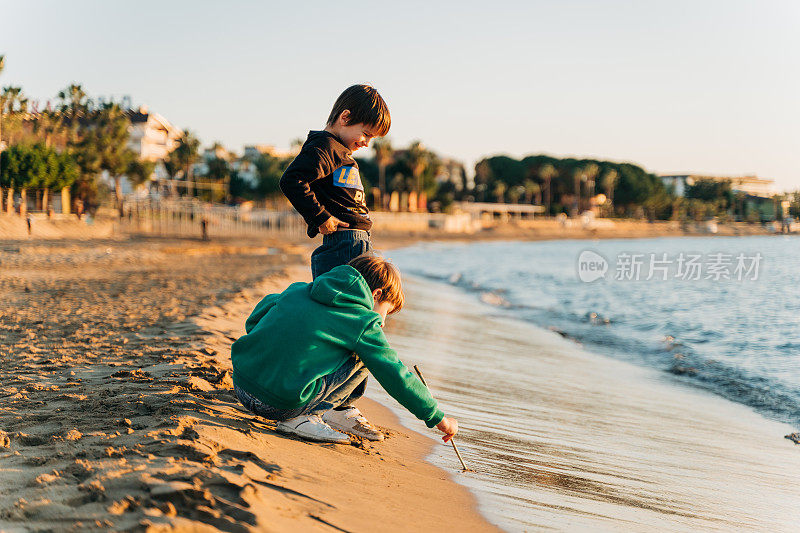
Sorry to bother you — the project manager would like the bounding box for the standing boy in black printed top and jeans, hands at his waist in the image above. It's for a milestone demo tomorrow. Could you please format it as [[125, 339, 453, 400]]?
[[280, 85, 392, 278]]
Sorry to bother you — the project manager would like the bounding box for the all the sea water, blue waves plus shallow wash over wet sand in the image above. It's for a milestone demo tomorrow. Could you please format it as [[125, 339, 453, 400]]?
[[370, 237, 800, 531]]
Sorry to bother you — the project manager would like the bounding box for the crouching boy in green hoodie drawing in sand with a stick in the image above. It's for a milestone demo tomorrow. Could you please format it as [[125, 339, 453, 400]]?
[[231, 255, 458, 443]]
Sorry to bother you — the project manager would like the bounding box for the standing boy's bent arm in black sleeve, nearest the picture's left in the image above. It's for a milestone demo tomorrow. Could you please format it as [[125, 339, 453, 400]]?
[[279, 146, 333, 228]]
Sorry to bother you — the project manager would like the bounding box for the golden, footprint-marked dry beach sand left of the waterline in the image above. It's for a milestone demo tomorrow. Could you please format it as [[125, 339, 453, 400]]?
[[0, 240, 493, 532]]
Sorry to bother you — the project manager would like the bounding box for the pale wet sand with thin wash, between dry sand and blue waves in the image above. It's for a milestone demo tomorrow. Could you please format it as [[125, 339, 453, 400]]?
[[378, 272, 800, 531]]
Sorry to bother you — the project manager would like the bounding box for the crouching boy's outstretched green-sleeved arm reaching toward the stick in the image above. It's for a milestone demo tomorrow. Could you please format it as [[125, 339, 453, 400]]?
[[354, 316, 444, 428]]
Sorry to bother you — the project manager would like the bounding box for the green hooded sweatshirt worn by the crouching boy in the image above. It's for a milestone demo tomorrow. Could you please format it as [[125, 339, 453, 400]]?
[[231, 265, 444, 427]]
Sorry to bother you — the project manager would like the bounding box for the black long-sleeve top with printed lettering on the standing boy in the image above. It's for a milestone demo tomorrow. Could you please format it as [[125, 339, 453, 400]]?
[[280, 131, 372, 237]]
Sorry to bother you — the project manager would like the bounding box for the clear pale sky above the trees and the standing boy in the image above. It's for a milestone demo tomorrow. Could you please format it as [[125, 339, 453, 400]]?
[[0, 0, 800, 190]]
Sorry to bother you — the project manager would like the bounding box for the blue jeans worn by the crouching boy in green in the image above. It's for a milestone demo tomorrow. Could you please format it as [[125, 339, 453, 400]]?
[[233, 355, 369, 421]]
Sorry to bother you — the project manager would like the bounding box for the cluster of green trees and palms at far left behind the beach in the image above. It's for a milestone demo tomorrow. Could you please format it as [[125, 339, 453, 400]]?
[[0, 56, 153, 212]]
